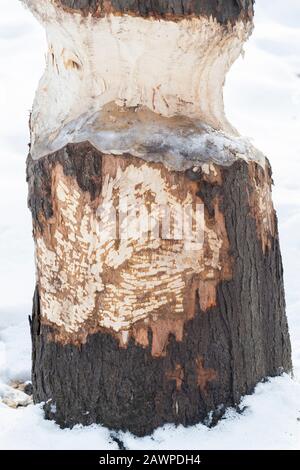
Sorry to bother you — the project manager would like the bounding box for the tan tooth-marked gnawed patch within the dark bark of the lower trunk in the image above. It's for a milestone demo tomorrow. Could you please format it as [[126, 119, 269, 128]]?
[[28, 144, 232, 357]]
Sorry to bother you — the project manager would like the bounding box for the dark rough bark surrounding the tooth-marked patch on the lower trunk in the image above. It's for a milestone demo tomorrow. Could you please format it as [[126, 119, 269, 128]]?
[[28, 144, 292, 436]]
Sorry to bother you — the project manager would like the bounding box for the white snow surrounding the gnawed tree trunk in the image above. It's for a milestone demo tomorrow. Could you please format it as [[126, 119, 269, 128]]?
[[0, 0, 300, 449]]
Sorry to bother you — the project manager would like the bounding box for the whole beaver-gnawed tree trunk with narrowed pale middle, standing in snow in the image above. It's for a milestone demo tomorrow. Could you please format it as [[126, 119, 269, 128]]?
[[25, 0, 292, 435]]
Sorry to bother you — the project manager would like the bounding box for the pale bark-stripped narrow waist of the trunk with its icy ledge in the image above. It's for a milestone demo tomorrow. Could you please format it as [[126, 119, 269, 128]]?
[[20, 0, 263, 170]]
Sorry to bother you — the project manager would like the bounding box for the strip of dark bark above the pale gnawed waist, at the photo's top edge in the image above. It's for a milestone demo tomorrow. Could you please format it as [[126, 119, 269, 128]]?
[[56, 0, 254, 23]]
